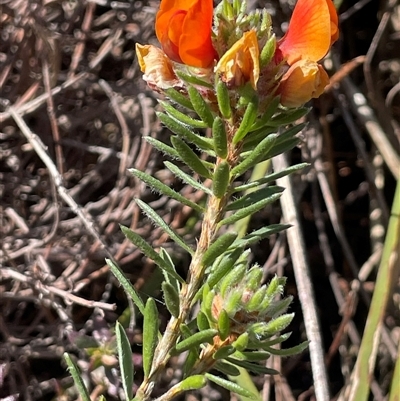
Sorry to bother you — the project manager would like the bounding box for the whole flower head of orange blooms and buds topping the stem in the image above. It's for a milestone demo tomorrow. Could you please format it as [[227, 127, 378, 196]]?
[[136, 0, 339, 108]]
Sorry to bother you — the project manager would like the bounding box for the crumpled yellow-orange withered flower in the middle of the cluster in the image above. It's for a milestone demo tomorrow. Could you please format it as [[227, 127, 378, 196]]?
[[215, 30, 260, 89]]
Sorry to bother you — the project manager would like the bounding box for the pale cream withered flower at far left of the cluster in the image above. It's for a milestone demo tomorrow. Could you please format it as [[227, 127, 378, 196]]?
[[136, 43, 180, 89]]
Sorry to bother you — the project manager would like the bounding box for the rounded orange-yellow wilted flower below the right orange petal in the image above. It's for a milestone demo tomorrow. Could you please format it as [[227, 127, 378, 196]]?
[[277, 60, 329, 107]]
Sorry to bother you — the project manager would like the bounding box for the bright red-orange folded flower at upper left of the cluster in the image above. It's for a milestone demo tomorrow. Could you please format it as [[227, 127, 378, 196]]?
[[156, 0, 216, 68]]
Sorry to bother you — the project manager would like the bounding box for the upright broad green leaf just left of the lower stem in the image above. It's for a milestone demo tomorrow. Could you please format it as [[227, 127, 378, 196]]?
[[143, 298, 158, 377]]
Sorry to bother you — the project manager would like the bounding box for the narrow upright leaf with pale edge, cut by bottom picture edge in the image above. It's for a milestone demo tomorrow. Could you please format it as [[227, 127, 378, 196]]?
[[115, 321, 134, 400]]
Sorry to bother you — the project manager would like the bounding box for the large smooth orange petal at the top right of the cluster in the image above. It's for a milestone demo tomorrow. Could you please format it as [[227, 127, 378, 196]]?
[[278, 0, 339, 65]]
